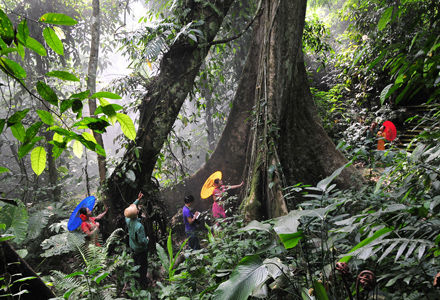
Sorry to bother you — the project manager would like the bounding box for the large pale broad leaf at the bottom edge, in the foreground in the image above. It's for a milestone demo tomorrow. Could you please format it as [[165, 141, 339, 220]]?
[[213, 255, 269, 300]]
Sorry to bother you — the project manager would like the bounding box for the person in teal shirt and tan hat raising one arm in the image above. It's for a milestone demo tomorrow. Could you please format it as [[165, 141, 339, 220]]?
[[124, 192, 148, 288]]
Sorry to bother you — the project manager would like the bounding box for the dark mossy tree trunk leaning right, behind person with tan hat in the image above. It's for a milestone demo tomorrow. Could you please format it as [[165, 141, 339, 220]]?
[[105, 0, 237, 237]]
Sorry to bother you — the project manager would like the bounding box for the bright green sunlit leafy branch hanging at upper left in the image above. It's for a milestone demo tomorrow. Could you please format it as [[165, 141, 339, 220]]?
[[0, 10, 136, 175]]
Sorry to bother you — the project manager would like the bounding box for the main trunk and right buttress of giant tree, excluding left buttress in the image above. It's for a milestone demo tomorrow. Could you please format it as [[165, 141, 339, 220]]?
[[243, 0, 356, 219]]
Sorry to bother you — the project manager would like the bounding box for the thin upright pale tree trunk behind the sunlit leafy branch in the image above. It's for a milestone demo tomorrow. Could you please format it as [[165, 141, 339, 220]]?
[[87, 0, 107, 184]]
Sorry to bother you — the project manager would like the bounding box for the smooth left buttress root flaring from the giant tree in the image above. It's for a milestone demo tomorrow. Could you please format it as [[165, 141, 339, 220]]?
[[162, 22, 261, 214]]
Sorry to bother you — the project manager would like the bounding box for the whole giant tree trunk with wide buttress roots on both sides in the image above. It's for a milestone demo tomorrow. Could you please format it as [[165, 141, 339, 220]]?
[[164, 0, 358, 219]]
